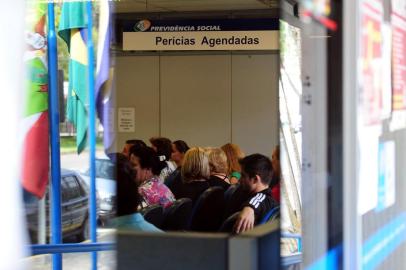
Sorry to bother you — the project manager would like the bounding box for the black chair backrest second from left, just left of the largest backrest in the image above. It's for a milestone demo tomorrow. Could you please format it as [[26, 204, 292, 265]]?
[[162, 198, 193, 231]]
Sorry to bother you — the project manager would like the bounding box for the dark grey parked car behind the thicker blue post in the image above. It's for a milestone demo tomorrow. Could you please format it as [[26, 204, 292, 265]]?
[[24, 169, 89, 243]]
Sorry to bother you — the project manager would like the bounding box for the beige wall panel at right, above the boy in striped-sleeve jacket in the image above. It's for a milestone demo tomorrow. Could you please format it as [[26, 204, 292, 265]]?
[[232, 54, 279, 155]]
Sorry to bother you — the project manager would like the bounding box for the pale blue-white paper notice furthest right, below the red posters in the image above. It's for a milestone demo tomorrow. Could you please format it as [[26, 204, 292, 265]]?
[[376, 141, 396, 211]]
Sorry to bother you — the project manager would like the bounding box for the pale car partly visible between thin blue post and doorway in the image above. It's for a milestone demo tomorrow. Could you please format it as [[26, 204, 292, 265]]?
[[82, 158, 117, 225]]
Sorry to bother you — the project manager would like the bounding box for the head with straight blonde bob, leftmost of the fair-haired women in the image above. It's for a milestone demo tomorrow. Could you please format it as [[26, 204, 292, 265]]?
[[181, 147, 210, 183]]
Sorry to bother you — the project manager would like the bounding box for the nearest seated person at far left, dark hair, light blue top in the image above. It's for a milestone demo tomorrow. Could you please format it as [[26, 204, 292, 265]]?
[[108, 153, 162, 232]]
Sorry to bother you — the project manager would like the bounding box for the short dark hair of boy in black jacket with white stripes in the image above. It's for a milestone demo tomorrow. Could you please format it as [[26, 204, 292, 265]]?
[[239, 154, 272, 185]]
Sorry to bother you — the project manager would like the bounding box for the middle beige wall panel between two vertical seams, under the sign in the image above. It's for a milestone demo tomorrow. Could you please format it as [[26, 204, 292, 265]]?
[[161, 55, 231, 146]]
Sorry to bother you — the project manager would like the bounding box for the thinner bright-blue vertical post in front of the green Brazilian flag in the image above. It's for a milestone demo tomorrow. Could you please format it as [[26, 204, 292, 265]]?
[[86, 0, 97, 270]]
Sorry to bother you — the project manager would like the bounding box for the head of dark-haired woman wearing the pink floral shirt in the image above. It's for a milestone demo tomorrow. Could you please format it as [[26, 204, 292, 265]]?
[[130, 147, 166, 183]]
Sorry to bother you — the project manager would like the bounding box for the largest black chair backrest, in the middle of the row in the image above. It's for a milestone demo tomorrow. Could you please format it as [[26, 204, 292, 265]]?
[[189, 187, 224, 232]]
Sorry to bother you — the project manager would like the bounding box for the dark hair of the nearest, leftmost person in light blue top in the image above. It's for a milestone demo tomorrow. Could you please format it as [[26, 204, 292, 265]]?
[[109, 153, 142, 216]]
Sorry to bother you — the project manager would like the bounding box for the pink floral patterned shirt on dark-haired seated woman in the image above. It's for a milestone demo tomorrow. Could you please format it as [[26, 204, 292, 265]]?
[[138, 176, 175, 208]]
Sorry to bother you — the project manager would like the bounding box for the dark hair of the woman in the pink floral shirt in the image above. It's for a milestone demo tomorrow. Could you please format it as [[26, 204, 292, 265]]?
[[130, 146, 166, 175]]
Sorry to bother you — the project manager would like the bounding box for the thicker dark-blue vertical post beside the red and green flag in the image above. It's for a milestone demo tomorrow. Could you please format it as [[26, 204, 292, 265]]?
[[48, 1, 62, 270]]
